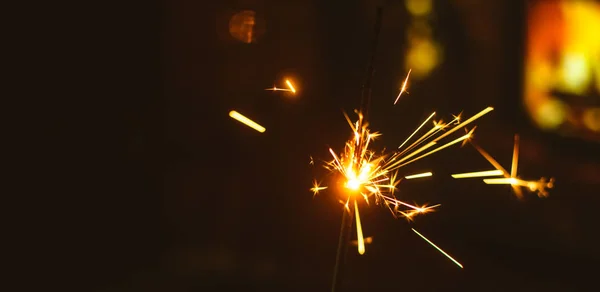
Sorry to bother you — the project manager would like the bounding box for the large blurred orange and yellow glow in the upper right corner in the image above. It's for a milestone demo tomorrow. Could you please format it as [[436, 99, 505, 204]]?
[[524, 0, 600, 137]]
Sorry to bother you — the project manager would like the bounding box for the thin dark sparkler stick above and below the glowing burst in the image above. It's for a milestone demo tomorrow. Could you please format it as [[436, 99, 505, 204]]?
[[331, 7, 383, 292]]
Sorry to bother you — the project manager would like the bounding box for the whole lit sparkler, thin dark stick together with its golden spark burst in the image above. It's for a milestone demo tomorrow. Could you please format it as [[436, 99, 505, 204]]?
[[314, 7, 502, 291]]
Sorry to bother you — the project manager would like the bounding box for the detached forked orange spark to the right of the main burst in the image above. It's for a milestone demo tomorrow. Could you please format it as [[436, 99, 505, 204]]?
[[452, 135, 554, 198]]
